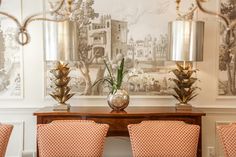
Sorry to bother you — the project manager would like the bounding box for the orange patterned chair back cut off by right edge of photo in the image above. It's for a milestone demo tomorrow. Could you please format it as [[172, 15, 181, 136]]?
[[217, 123, 236, 157]]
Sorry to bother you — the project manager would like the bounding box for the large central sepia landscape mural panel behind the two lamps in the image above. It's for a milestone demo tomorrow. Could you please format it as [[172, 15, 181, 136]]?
[[44, 0, 195, 98]]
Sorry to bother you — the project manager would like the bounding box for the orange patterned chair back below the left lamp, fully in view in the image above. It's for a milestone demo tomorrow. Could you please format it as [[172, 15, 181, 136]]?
[[37, 121, 109, 157]]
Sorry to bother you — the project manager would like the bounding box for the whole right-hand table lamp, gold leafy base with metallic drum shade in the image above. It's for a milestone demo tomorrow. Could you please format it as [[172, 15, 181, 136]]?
[[168, 20, 204, 110]]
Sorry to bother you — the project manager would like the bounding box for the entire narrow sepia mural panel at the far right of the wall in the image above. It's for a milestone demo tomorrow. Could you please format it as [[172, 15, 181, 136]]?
[[218, 0, 236, 96]]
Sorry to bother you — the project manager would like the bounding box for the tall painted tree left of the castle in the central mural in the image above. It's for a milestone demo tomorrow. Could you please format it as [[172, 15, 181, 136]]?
[[75, 0, 104, 95]]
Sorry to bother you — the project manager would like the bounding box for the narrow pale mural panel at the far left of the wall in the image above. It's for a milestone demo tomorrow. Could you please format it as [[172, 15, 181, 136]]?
[[0, 0, 23, 99]]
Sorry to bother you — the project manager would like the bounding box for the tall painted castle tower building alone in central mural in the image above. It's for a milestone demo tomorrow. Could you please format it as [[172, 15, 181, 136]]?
[[88, 15, 128, 60]]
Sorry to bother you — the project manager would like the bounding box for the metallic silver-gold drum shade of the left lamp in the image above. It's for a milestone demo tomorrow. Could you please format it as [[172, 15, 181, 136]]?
[[45, 20, 79, 61]]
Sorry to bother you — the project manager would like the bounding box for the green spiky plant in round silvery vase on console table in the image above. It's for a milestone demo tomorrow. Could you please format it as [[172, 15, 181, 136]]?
[[94, 58, 129, 111]]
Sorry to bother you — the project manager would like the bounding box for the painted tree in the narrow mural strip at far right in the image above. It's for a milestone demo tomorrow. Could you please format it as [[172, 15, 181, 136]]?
[[219, 0, 236, 95]]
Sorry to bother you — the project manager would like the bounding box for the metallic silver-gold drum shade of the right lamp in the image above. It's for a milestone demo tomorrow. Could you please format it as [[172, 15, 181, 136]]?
[[167, 21, 204, 61]]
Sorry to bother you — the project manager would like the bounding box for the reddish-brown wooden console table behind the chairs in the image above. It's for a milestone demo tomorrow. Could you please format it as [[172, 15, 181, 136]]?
[[34, 107, 205, 157]]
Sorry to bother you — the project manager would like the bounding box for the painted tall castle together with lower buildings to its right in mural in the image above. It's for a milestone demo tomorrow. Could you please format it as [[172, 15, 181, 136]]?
[[88, 15, 167, 66]]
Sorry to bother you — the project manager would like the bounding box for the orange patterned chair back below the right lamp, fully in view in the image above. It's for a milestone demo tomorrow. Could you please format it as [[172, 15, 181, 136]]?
[[128, 121, 200, 157]]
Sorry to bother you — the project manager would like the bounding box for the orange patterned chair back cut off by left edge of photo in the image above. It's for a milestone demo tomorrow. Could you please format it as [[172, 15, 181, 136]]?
[[0, 124, 13, 157]]
